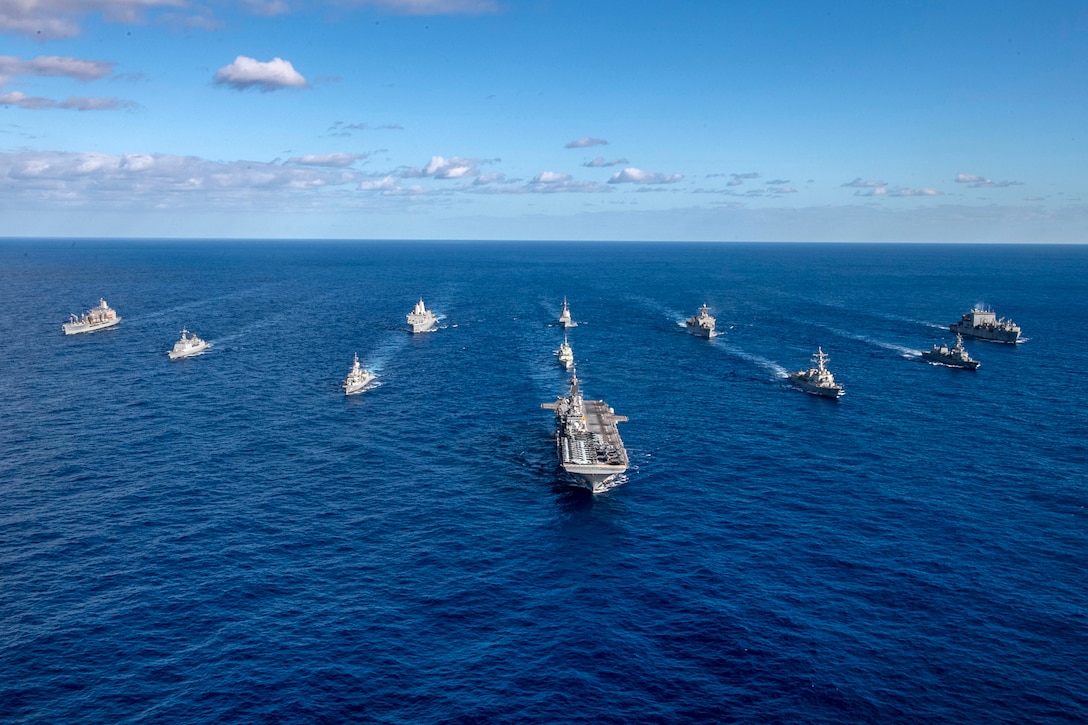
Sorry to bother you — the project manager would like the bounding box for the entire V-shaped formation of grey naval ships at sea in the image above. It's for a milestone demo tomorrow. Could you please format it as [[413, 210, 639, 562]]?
[[62, 297, 1022, 493]]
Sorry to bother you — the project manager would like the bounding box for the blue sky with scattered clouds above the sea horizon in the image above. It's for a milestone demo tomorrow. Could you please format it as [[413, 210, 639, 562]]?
[[0, 0, 1088, 243]]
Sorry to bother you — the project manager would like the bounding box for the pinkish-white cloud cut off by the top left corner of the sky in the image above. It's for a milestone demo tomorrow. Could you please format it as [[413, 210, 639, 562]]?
[[0, 0, 186, 40]]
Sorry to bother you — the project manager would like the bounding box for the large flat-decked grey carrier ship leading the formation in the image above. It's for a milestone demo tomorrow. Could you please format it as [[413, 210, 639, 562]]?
[[541, 370, 628, 493]]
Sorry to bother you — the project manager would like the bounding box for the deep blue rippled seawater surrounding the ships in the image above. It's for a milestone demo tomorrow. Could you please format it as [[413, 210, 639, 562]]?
[[0, 241, 1088, 723]]
